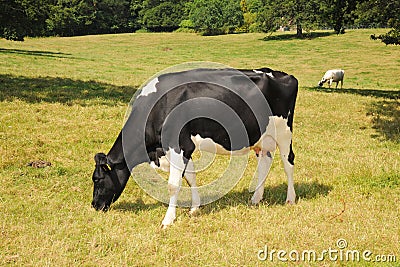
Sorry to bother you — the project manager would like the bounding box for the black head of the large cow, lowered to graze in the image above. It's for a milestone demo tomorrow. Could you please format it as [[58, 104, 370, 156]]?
[[92, 153, 123, 211]]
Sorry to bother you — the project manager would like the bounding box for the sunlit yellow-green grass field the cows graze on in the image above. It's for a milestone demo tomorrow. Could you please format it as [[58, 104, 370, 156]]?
[[0, 30, 400, 266]]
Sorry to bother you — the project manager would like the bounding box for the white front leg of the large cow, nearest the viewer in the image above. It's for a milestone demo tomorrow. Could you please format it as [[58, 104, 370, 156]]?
[[161, 149, 185, 229]]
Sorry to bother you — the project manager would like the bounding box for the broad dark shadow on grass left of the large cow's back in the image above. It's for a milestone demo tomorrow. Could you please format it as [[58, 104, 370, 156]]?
[[0, 75, 136, 106]]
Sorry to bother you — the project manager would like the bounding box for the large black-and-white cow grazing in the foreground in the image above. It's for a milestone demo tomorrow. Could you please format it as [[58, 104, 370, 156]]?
[[92, 68, 298, 227]]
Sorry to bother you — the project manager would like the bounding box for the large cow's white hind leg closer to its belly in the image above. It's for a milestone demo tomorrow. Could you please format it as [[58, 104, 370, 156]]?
[[251, 151, 272, 205]]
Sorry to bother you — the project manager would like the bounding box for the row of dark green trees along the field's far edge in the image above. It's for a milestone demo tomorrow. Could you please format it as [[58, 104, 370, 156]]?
[[0, 0, 400, 44]]
